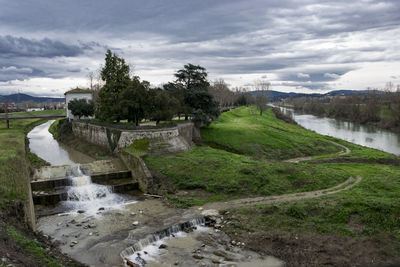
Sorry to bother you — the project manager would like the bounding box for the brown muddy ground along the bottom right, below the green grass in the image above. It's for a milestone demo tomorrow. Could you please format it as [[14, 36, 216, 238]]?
[[224, 226, 400, 267]]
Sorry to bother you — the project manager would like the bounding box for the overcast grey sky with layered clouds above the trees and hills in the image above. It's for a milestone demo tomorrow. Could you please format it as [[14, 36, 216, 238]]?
[[0, 0, 400, 96]]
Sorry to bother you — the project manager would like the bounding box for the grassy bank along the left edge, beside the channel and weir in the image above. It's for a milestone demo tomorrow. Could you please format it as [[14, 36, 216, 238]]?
[[0, 112, 83, 267]]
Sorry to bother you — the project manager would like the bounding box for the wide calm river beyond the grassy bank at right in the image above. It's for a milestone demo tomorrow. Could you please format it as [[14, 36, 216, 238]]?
[[281, 107, 400, 155]]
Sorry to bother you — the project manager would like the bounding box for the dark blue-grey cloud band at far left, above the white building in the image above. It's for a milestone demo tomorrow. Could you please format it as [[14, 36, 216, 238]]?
[[0, 35, 83, 58]]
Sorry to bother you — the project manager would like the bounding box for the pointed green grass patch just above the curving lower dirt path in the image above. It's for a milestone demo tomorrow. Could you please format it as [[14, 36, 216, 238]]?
[[145, 146, 349, 205]]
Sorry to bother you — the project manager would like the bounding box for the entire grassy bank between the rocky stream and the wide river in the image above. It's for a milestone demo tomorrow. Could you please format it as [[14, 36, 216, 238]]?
[[145, 108, 400, 266]]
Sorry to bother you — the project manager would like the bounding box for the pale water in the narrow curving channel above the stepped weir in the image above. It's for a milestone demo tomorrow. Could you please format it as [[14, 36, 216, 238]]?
[[28, 120, 93, 166]]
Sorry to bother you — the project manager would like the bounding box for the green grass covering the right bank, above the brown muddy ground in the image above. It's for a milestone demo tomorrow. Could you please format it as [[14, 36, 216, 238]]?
[[145, 105, 400, 250]]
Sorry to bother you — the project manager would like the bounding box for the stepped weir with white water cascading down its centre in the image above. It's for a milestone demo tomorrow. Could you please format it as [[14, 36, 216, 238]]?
[[31, 160, 138, 209]]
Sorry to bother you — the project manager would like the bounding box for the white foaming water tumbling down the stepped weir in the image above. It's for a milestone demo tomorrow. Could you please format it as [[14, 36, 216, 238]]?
[[62, 165, 132, 216]]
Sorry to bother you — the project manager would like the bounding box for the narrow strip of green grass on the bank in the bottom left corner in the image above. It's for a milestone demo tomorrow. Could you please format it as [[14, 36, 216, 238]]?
[[5, 225, 63, 267]]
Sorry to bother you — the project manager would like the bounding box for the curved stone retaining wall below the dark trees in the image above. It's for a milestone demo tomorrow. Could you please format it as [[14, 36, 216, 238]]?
[[72, 121, 195, 154]]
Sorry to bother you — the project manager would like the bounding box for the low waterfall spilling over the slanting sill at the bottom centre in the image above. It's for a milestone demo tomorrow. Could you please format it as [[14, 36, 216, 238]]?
[[120, 217, 206, 266]]
